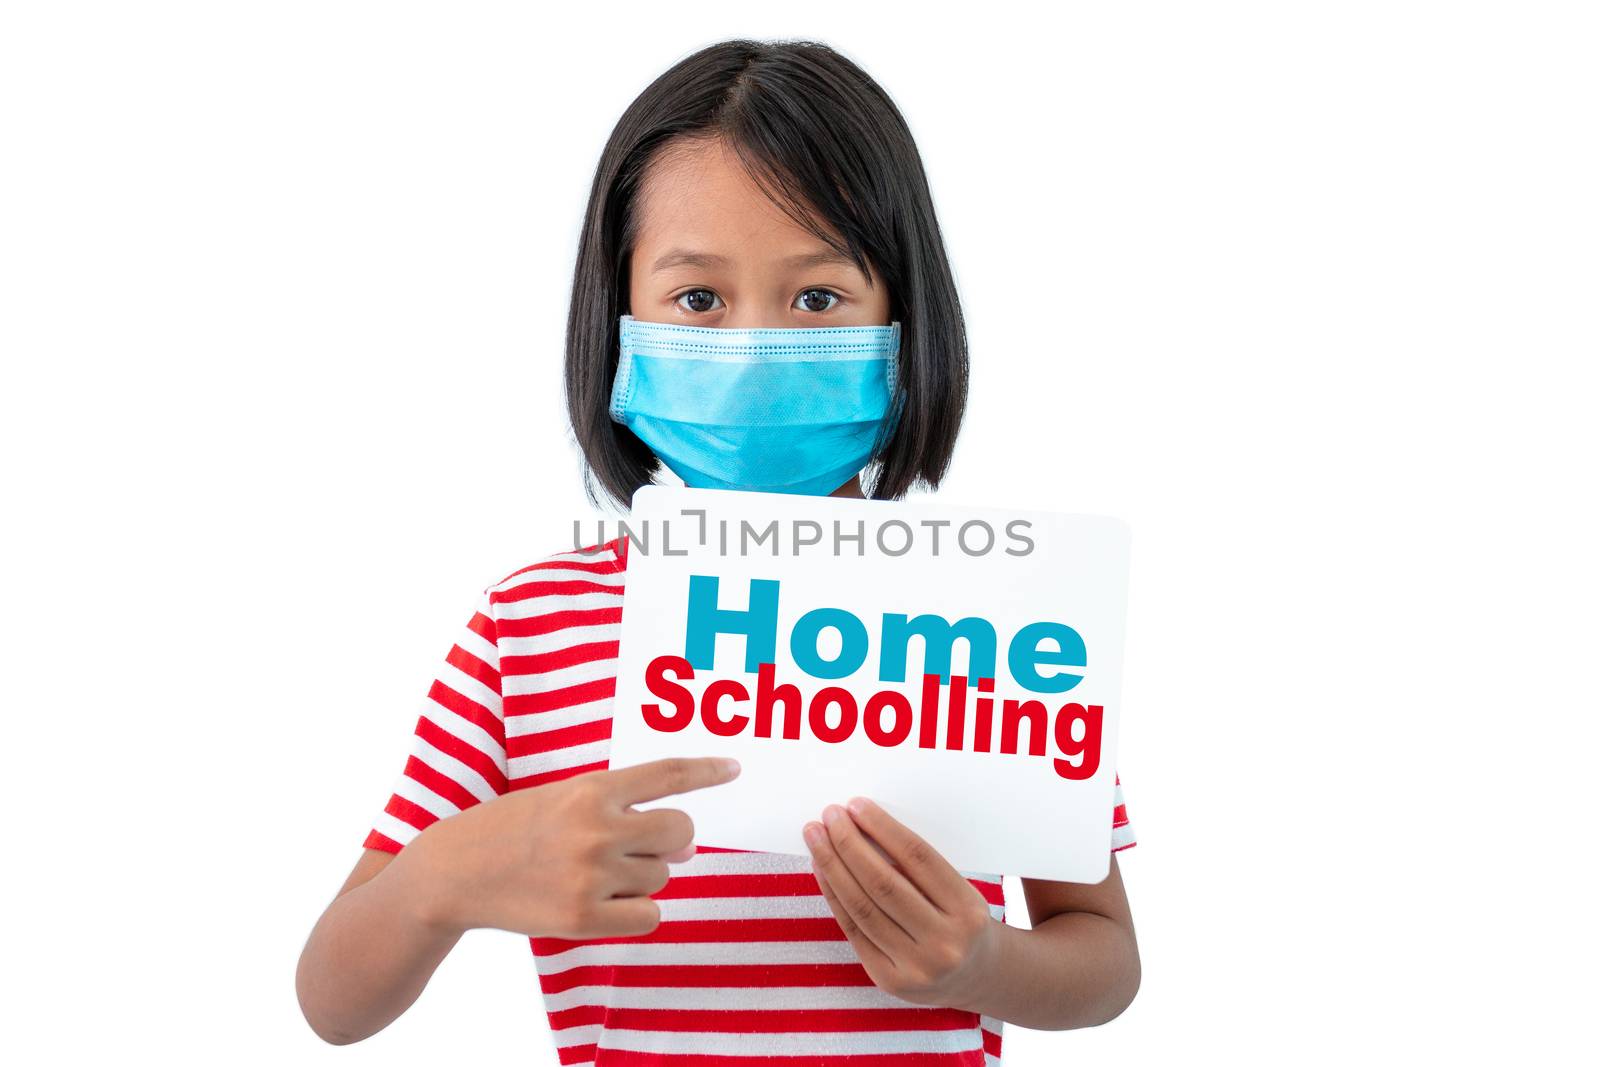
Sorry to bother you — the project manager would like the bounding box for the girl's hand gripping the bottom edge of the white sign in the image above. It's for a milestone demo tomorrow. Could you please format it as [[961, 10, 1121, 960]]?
[[802, 797, 1000, 1008]]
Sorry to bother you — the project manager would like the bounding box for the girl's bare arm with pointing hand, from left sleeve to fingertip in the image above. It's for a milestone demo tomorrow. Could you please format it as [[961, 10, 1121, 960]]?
[[294, 757, 739, 1045]]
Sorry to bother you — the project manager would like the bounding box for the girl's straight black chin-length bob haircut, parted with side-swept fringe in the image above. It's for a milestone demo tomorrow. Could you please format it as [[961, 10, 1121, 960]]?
[[565, 38, 968, 509]]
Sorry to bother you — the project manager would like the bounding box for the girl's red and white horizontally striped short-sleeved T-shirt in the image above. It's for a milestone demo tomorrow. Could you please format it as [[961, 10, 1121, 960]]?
[[365, 537, 1134, 1067]]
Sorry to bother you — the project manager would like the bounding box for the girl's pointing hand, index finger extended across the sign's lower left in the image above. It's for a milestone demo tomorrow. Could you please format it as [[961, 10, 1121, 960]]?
[[395, 757, 738, 939]]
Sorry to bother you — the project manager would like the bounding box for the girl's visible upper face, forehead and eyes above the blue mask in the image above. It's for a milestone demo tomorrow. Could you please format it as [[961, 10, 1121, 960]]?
[[629, 141, 890, 328]]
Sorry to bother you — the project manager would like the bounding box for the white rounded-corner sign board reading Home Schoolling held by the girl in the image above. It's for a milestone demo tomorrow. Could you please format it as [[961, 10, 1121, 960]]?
[[610, 486, 1128, 881]]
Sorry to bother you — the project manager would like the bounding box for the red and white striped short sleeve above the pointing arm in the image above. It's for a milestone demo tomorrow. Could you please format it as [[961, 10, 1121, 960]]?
[[365, 589, 507, 853]]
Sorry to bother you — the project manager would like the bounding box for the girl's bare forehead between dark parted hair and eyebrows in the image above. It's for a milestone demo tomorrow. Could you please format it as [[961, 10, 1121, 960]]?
[[634, 141, 857, 270]]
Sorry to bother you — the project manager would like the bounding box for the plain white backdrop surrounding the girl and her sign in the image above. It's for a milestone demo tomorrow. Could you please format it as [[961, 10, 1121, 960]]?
[[0, 2, 1600, 1067]]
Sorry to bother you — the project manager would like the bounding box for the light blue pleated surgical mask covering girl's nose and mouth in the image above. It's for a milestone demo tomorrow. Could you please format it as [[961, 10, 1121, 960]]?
[[611, 315, 904, 496]]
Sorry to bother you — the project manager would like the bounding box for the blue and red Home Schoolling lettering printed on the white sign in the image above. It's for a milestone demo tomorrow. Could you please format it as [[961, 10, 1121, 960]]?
[[640, 574, 1104, 781]]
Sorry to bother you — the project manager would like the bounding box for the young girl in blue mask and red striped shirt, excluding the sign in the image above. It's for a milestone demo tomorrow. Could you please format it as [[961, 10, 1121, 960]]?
[[296, 40, 1139, 1067]]
